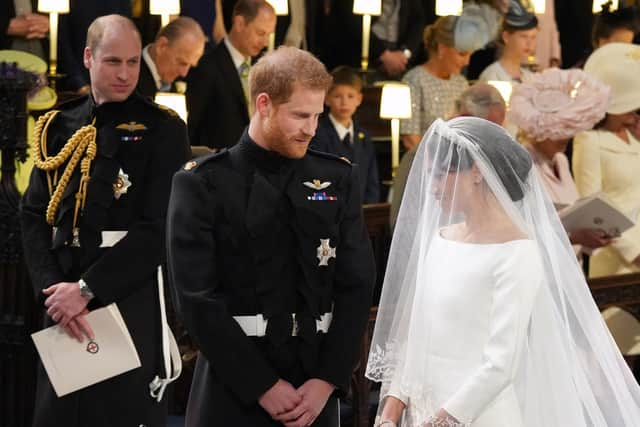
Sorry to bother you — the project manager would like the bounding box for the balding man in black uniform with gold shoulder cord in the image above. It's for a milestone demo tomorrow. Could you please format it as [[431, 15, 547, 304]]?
[[21, 15, 189, 427]]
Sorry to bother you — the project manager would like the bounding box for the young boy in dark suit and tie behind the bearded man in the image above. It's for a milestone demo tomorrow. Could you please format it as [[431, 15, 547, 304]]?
[[311, 66, 380, 203]]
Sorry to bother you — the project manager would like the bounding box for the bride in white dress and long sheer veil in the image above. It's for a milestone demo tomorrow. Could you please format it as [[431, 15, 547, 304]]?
[[367, 117, 640, 427]]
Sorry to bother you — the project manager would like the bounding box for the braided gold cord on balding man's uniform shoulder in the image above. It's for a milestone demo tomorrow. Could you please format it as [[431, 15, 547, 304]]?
[[33, 110, 98, 243]]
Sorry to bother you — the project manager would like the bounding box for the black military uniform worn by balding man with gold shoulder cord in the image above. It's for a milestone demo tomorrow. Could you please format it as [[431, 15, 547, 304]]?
[[21, 94, 189, 426]]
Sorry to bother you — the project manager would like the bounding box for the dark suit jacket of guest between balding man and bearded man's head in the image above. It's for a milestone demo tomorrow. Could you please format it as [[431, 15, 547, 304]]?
[[187, 42, 249, 148]]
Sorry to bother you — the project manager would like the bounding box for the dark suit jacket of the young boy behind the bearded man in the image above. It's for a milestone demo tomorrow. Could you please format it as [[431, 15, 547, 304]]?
[[311, 114, 380, 203]]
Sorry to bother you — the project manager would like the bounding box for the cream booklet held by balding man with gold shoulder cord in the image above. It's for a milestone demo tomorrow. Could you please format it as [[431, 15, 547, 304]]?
[[31, 304, 140, 397]]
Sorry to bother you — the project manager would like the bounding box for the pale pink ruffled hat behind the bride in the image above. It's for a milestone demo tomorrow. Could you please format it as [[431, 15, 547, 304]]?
[[508, 68, 610, 141]]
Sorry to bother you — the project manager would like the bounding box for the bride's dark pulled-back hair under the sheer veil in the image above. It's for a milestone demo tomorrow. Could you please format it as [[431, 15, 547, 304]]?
[[424, 116, 532, 202]]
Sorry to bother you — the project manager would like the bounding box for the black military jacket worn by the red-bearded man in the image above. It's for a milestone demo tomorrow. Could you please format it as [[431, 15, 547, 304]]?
[[167, 131, 375, 414]]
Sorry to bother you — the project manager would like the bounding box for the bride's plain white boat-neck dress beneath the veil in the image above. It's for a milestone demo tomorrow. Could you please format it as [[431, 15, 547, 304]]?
[[387, 234, 543, 427]]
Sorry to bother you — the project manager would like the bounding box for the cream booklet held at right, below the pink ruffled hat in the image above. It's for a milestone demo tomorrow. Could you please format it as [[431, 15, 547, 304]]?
[[558, 193, 635, 237]]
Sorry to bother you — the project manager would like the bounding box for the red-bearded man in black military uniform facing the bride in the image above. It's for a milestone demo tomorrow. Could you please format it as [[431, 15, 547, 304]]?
[[167, 47, 374, 427]]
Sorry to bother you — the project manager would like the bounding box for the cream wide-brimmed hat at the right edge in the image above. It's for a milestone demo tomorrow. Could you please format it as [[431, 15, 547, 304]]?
[[584, 43, 640, 114]]
